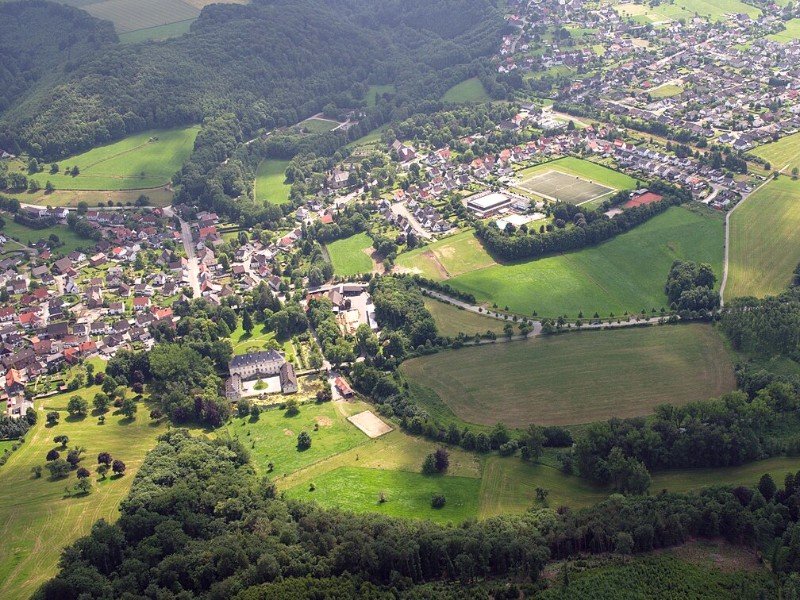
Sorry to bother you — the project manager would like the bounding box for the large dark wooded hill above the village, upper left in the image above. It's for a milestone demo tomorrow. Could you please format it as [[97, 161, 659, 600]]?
[[0, 0, 503, 159]]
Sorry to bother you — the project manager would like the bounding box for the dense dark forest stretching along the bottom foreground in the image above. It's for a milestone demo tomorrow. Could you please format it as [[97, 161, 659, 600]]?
[[35, 430, 800, 600]]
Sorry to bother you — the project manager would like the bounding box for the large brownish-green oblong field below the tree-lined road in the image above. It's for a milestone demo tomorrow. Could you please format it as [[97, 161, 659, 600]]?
[[402, 324, 736, 427]]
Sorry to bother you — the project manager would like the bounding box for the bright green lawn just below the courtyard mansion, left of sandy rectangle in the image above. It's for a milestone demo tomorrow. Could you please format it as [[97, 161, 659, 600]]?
[[227, 402, 369, 476]]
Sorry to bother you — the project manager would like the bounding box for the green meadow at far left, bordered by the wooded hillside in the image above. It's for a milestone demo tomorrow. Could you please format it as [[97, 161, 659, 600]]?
[[25, 126, 200, 190]]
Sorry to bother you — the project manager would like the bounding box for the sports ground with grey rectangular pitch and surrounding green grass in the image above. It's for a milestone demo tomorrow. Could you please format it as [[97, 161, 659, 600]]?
[[516, 156, 640, 204]]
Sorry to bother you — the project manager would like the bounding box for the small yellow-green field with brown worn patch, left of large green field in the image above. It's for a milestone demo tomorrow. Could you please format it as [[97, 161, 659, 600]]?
[[395, 229, 497, 281]]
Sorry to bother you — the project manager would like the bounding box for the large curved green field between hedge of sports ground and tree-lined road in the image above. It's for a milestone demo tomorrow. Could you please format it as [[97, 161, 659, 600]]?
[[450, 207, 724, 319]]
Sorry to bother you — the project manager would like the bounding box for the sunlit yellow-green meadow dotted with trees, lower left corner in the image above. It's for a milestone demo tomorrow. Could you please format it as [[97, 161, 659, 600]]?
[[0, 387, 166, 600]]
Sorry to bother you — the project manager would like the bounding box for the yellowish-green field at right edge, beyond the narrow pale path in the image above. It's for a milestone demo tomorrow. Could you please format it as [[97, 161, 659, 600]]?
[[725, 177, 800, 300]]
